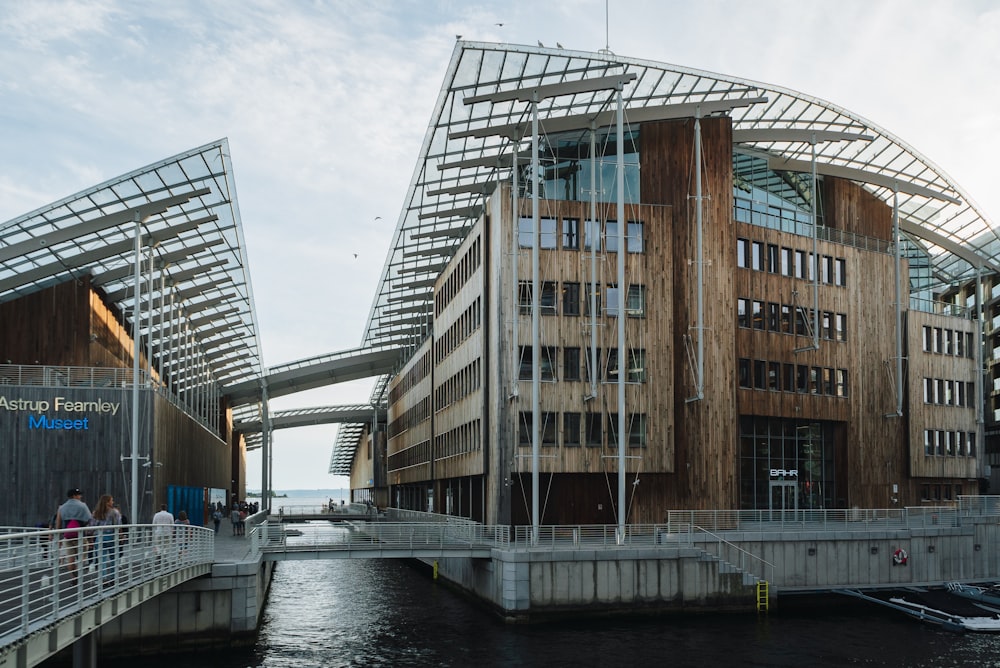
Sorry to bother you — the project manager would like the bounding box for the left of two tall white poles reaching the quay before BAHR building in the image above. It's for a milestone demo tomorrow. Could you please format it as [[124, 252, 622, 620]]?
[[531, 93, 542, 544]]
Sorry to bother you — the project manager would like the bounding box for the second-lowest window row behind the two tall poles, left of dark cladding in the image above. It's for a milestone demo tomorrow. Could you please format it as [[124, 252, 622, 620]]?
[[517, 346, 646, 383]]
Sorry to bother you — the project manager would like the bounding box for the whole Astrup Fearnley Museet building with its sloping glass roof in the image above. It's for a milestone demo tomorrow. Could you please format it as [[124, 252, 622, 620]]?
[[0, 139, 264, 526]]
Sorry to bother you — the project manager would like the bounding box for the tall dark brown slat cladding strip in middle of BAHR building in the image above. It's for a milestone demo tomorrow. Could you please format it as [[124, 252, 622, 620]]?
[[640, 118, 737, 508]]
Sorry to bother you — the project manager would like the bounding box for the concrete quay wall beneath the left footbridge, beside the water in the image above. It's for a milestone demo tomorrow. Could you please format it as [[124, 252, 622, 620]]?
[[97, 561, 274, 657]]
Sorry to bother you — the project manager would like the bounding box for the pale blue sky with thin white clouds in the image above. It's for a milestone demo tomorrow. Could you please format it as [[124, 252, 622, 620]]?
[[0, 0, 1000, 490]]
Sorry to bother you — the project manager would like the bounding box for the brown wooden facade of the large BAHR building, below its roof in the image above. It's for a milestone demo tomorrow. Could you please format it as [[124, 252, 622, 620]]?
[[388, 117, 977, 524]]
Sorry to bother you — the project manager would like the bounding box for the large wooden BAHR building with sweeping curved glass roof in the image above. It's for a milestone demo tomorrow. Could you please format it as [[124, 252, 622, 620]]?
[[331, 41, 1000, 524]]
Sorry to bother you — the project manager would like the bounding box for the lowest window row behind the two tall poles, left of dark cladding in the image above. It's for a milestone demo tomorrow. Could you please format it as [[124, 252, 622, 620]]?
[[518, 411, 647, 448]]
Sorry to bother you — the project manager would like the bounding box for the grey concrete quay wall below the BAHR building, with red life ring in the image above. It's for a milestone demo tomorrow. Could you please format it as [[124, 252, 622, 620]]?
[[438, 518, 1000, 621]]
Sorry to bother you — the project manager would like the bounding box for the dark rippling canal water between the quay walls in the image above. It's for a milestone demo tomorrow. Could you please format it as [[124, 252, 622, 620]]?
[[100, 559, 1000, 668]]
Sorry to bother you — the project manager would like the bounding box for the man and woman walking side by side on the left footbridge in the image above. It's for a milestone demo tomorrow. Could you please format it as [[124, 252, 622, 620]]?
[[52, 487, 128, 581]]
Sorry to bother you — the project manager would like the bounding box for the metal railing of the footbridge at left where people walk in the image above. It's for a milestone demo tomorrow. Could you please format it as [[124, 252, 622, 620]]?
[[0, 524, 215, 650]]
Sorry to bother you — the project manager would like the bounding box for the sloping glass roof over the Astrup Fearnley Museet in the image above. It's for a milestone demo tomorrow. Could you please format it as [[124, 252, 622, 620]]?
[[0, 139, 262, 410]]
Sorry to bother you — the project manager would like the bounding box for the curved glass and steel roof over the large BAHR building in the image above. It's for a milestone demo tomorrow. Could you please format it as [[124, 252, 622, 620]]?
[[363, 41, 1000, 346]]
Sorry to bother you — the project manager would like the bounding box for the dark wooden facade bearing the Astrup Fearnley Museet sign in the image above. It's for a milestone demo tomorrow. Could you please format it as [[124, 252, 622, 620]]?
[[0, 276, 246, 526]]
